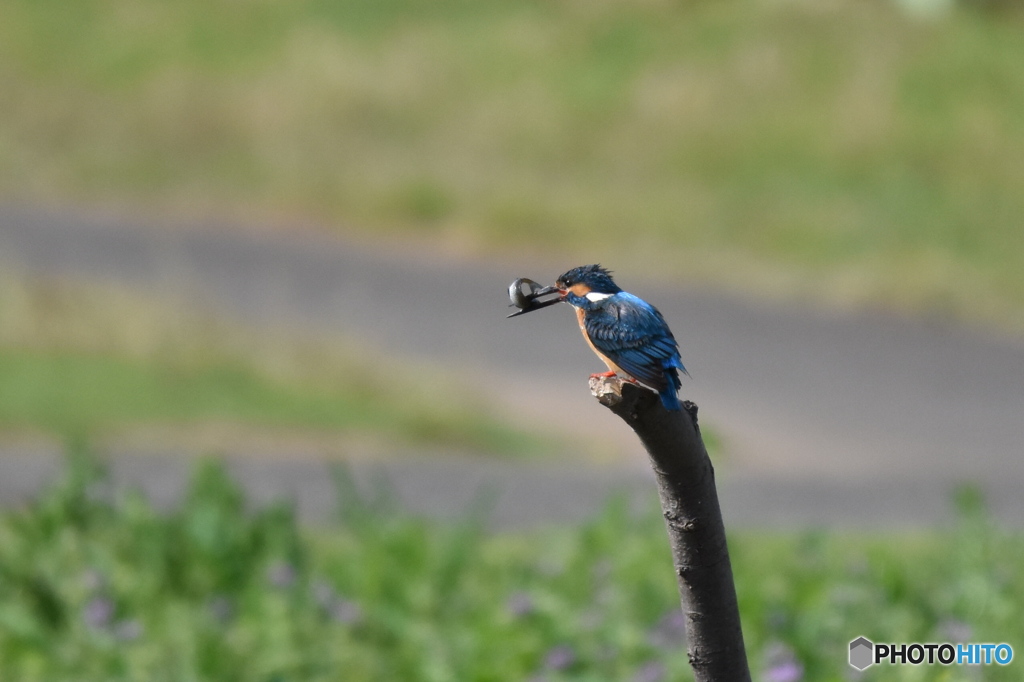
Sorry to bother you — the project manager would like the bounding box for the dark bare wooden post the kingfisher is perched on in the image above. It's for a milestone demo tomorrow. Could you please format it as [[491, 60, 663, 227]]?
[[590, 377, 751, 682]]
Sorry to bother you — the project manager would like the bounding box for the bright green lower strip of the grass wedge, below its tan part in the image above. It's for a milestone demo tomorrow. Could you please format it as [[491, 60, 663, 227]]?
[[0, 348, 543, 455]]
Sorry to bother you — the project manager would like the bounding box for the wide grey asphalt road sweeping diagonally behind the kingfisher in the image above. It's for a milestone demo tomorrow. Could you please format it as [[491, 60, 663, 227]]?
[[0, 207, 1024, 521]]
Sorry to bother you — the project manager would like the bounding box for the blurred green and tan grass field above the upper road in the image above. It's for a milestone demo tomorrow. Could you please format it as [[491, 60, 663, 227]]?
[[0, 0, 1024, 329]]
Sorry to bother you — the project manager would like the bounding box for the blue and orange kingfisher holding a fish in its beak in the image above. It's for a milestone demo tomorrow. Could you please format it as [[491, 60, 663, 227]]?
[[510, 264, 689, 410]]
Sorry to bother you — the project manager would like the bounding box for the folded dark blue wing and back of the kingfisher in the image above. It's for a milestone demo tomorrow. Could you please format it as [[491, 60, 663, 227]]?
[[584, 292, 682, 390]]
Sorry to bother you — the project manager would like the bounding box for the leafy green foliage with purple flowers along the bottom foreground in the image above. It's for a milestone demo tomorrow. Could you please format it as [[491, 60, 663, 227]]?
[[0, 452, 1024, 682]]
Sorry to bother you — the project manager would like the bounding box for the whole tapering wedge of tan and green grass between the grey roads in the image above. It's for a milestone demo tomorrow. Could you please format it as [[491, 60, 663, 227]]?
[[0, 275, 558, 456]]
